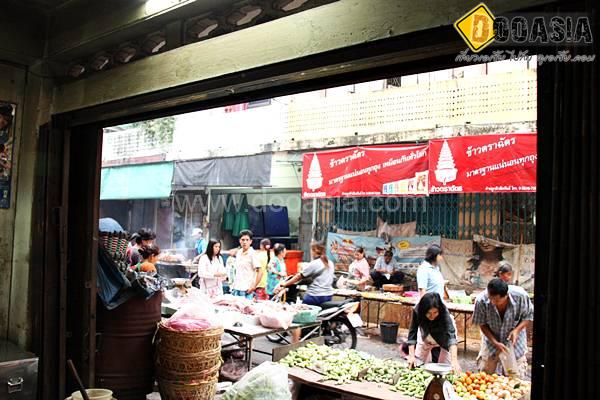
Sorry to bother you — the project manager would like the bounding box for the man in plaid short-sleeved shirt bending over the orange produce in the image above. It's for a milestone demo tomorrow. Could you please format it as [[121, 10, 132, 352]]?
[[473, 278, 533, 378]]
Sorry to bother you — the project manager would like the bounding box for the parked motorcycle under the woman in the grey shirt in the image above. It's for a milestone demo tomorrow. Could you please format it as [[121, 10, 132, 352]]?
[[267, 299, 362, 349]]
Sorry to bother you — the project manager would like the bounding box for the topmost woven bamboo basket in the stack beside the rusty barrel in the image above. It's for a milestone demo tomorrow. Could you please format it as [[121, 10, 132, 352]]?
[[157, 323, 223, 354]]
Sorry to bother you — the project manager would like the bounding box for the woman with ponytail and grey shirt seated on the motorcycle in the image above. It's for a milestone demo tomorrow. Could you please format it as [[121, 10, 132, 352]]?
[[276, 242, 335, 306]]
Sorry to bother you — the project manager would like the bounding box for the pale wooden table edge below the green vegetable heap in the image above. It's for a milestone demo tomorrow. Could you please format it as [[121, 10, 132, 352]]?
[[288, 368, 414, 400]]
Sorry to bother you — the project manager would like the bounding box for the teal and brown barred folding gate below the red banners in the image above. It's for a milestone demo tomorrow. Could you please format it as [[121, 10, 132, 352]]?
[[315, 193, 535, 244]]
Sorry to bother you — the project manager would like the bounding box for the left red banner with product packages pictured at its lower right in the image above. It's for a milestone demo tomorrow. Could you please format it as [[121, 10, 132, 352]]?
[[302, 145, 429, 199]]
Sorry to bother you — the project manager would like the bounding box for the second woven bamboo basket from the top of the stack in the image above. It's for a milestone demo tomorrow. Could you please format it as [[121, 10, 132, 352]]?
[[156, 349, 222, 380]]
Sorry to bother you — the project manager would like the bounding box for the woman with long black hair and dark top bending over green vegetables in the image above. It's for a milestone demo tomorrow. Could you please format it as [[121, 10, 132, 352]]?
[[406, 292, 461, 373]]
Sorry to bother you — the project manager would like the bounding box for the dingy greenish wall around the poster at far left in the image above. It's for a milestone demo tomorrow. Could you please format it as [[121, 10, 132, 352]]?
[[0, 64, 52, 347]]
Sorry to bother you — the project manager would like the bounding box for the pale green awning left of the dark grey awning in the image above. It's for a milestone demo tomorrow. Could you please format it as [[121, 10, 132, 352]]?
[[100, 162, 173, 200]]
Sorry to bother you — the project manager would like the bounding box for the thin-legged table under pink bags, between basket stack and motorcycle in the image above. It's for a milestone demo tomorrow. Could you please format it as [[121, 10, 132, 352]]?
[[221, 322, 321, 370]]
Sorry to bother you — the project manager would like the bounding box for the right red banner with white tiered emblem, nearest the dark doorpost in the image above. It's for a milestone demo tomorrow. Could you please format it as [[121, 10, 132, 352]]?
[[429, 133, 537, 194]]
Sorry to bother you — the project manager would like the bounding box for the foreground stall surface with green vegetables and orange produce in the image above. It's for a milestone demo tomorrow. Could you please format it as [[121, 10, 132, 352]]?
[[279, 343, 530, 400]]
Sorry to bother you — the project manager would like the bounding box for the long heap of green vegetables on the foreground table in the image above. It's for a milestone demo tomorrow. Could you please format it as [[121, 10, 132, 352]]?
[[280, 343, 440, 398]]
